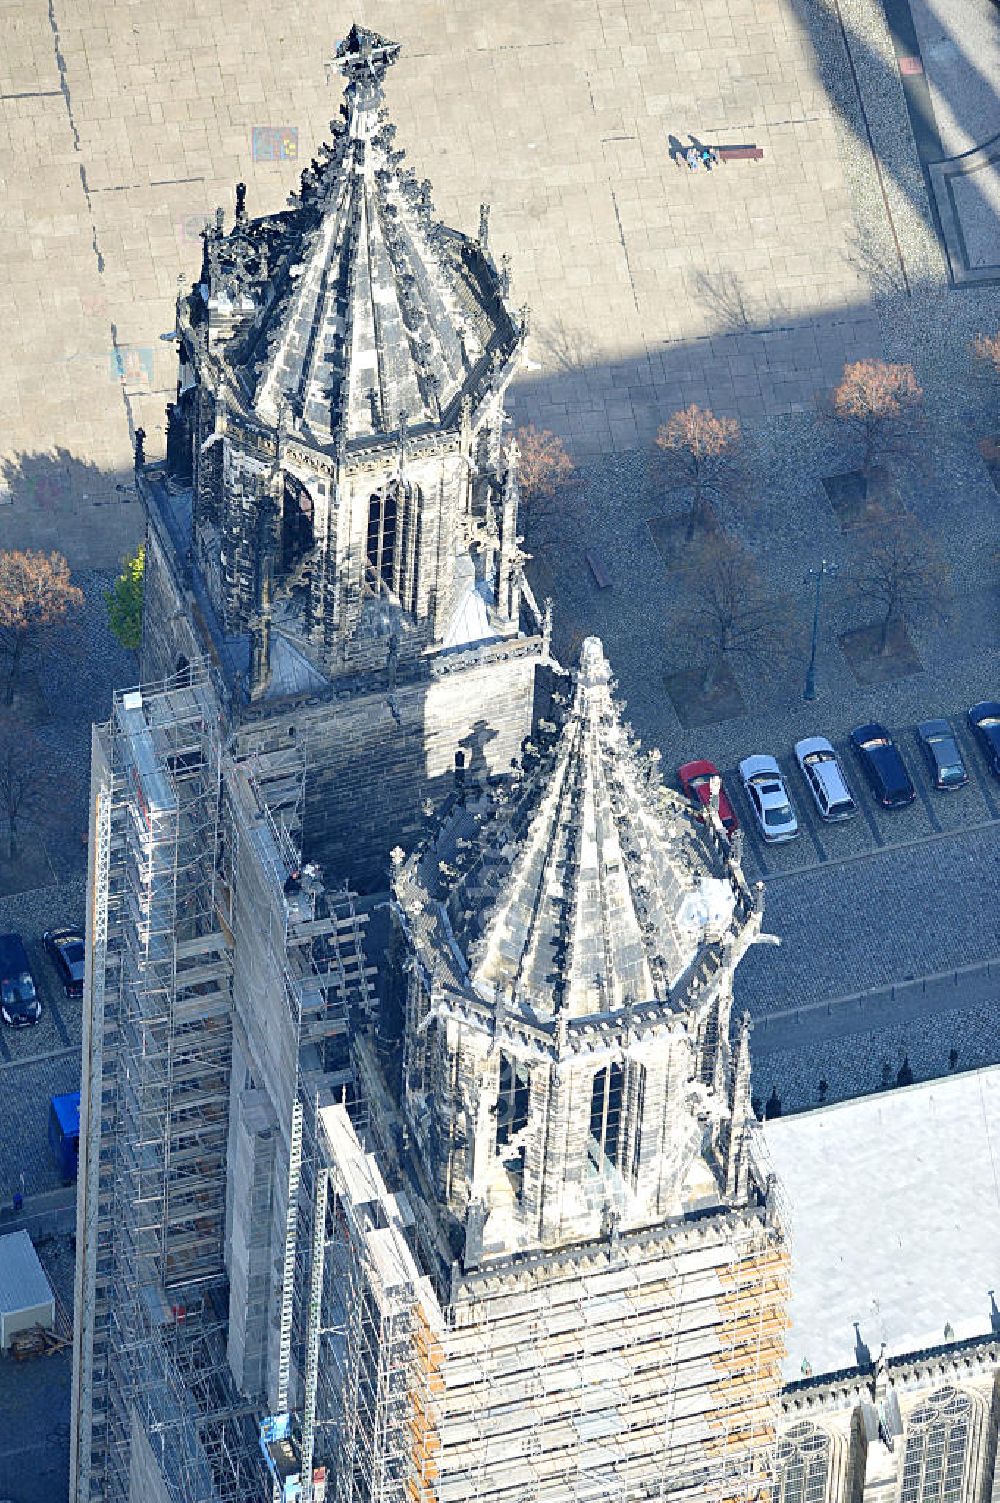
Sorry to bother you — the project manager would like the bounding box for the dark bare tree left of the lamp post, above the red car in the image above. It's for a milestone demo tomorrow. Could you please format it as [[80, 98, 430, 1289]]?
[[675, 532, 792, 694]]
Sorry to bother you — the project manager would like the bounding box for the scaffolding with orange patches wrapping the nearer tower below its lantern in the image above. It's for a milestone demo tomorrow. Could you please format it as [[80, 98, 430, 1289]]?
[[308, 1114, 788, 1503]]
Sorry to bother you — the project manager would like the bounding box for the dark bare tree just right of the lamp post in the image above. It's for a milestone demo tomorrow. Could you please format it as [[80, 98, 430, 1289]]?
[[851, 507, 949, 655]]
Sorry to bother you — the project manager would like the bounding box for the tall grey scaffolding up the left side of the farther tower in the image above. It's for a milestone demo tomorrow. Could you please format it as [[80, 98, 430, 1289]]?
[[75, 664, 273, 1503]]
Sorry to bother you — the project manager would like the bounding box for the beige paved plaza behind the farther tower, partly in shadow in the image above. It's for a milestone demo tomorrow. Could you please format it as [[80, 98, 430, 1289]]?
[[0, 0, 943, 567]]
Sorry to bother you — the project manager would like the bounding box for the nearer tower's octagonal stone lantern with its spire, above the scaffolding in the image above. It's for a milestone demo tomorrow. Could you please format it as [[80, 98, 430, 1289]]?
[[394, 637, 762, 1267]]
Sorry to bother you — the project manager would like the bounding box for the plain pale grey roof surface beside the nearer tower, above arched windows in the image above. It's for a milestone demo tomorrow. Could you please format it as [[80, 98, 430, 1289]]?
[[761, 1069, 1000, 1380]]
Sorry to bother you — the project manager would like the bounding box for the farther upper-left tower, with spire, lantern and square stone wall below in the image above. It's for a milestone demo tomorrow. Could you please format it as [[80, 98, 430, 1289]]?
[[141, 27, 547, 884]]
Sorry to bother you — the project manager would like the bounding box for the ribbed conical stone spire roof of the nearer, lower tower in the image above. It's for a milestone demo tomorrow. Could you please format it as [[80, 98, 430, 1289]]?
[[395, 637, 737, 1021]]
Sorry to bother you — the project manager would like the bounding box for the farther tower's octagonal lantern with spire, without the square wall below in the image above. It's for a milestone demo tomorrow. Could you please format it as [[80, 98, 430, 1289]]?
[[168, 26, 526, 696]]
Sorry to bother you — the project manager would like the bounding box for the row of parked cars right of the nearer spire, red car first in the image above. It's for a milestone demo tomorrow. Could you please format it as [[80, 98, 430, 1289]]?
[[677, 700, 1000, 845]]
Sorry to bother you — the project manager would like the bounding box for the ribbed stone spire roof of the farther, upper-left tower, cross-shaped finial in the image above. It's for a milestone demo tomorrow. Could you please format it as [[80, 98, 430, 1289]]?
[[225, 26, 520, 443]]
